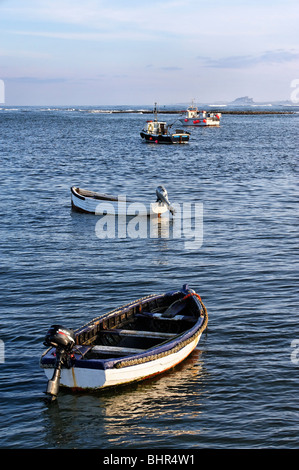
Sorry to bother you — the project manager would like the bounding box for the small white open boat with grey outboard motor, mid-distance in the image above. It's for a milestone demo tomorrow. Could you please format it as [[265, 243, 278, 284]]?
[[71, 185, 174, 217]]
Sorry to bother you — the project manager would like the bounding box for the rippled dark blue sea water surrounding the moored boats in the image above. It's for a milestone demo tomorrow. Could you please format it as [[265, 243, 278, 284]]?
[[0, 107, 299, 450]]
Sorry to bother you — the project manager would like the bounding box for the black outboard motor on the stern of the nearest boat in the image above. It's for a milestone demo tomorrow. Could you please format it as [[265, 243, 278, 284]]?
[[44, 325, 75, 401]]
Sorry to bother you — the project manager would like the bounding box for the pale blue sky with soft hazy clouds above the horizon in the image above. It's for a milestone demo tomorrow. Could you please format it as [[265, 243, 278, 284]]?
[[0, 0, 299, 106]]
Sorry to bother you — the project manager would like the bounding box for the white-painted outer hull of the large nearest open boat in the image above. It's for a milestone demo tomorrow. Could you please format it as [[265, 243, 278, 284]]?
[[44, 334, 201, 390]]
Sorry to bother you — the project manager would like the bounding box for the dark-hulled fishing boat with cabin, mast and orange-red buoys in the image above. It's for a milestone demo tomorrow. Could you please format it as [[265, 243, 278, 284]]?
[[140, 103, 190, 144]]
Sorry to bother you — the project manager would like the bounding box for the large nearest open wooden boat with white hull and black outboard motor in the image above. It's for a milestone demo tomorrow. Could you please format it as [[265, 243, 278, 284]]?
[[40, 284, 208, 401]]
